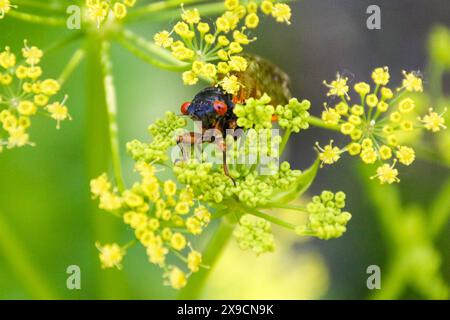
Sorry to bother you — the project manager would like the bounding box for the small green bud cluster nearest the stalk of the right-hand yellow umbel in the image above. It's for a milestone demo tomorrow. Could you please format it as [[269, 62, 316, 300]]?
[[275, 98, 311, 132]]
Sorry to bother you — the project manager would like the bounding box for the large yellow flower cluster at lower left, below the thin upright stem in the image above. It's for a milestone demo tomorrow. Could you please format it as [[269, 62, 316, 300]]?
[[91, 162, 211, 289]]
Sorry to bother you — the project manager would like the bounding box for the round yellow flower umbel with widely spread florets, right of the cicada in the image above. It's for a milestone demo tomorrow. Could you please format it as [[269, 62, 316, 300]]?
[[317, 67, 445, 184]]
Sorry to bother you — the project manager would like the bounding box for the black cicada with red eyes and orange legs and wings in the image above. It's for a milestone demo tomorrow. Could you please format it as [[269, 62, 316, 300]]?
[[178, 55, 291, 182]]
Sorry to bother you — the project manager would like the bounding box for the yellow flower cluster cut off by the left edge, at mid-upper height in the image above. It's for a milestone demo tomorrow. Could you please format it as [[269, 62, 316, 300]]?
[[0, 41, 70, 151]]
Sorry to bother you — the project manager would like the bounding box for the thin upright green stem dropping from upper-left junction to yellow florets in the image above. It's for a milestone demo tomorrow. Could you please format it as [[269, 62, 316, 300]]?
[[101, 41, 125, 192]]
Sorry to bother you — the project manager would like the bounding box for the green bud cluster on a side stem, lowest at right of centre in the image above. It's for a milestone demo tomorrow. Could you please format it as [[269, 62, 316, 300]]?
[[296, 191, 352, 240]]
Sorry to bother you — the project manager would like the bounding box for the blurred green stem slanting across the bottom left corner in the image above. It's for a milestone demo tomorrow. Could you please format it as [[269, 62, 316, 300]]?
[[0, 214, 57, 299]]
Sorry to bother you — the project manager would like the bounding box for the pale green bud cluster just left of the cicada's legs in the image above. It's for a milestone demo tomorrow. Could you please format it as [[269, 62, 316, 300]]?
[[127, 112, 186, 162]]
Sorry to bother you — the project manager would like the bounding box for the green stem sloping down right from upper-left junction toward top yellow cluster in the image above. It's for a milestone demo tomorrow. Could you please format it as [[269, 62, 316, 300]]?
[[116, 31, 189, 72]]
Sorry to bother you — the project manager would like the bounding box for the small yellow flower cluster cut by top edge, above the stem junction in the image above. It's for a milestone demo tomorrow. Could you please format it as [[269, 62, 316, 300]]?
[[85, 0, 136, 27]]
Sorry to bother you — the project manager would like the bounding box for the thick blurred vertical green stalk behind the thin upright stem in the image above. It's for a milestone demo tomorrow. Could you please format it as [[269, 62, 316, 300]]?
[[86, 34, 127, 299]]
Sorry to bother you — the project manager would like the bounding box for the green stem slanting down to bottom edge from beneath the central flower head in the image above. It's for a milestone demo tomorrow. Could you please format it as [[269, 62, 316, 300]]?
[[178, 214, 236, 300]]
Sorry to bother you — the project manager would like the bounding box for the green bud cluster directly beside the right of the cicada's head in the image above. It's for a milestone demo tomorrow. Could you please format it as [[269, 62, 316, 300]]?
[[233, 94, 275, 130]]
